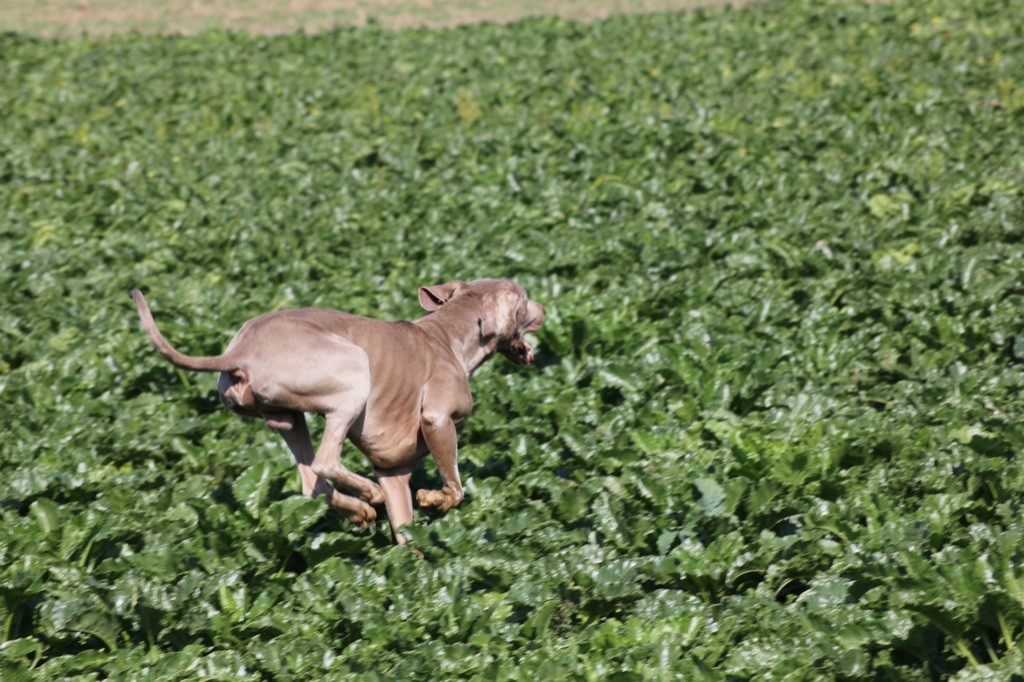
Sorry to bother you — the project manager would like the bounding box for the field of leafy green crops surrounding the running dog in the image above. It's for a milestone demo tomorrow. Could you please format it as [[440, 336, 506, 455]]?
[[0, 0, 1024, 681]]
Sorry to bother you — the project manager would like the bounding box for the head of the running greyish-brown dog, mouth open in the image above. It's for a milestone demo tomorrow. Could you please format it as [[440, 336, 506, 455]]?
[[420, 280, 546, 365]]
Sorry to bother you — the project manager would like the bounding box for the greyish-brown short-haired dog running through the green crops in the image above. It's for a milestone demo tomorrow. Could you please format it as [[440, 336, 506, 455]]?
[[131, 280, 547, 545]]
